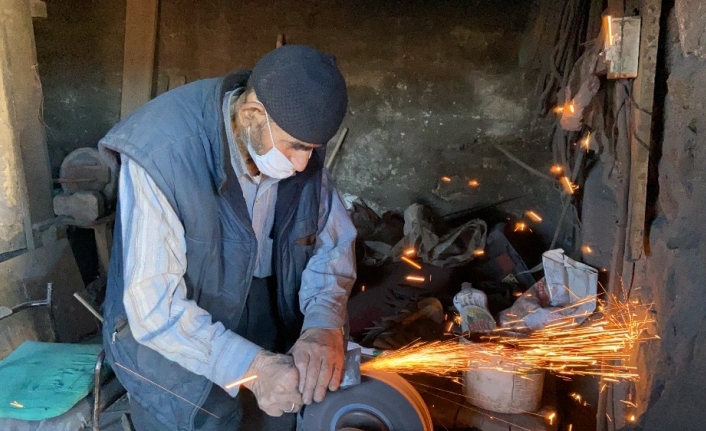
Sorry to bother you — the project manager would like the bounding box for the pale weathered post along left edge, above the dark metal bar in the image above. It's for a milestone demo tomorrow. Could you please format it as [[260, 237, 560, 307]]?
[[0, 0, 54, 254]]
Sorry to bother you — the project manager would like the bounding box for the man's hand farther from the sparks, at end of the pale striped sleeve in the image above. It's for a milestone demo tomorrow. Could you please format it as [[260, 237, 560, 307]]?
[[243, 350, 303, 417]]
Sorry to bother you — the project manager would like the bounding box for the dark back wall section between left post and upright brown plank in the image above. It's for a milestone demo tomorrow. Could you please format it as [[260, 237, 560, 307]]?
[[34, 0, 125, 177]]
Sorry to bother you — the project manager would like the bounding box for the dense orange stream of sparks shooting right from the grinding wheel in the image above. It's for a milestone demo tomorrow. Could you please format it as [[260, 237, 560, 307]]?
[[362, 302, 656, 382]]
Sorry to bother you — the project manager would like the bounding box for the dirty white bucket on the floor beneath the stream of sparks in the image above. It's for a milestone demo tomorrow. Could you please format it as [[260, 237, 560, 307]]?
[[464, 358, 544, 413]]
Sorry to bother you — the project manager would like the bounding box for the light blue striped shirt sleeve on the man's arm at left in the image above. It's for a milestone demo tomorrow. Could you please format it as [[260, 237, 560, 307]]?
[[119, 156, 262, 396]]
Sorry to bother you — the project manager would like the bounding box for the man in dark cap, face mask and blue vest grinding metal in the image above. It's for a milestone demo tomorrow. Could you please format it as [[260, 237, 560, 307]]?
[[99, 45, 355, 431]]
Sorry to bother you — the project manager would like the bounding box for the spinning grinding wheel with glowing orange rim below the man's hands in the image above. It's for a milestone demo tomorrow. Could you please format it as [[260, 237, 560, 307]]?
[[301, 371, 433, 431]]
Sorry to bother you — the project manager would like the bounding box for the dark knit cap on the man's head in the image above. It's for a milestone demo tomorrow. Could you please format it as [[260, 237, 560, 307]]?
[[248, 45, 348, 144]]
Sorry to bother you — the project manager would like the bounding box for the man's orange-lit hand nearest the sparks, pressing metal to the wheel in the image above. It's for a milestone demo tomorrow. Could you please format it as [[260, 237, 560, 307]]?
[[291, 328, 343, 405]]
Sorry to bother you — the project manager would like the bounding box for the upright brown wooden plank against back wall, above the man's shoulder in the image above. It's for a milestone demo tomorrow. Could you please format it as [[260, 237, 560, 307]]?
[[120, 0, 159, 118]]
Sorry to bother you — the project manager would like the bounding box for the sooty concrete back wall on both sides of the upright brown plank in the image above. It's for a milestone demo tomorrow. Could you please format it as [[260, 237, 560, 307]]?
[[37, 0, 556, 243]]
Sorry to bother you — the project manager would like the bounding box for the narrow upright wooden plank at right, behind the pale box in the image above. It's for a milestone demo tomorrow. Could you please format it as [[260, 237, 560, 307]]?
[[626, 0, 662, 261]]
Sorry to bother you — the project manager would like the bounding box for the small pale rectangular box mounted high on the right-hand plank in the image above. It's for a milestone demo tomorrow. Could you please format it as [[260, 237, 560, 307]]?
[[603, 15, 642, 79]]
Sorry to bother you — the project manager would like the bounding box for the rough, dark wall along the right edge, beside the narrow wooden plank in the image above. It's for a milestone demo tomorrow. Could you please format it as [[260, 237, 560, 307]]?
[[635, 0, 706, 431]]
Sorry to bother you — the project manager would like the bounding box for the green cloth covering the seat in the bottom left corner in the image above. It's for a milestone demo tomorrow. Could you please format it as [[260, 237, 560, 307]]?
[[0, 341, 103, 421]]
